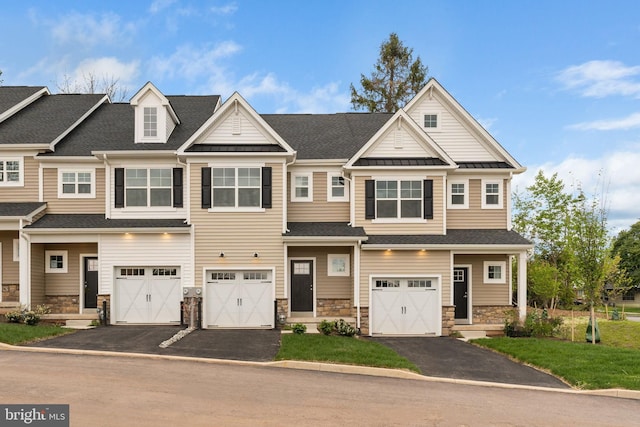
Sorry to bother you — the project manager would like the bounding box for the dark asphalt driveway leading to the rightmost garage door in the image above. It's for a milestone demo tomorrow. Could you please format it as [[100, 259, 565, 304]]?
[[371, 337, 570, 388]]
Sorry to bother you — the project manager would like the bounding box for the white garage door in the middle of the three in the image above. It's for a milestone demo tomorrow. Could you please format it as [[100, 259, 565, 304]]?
[[205, 270, 274, 328]]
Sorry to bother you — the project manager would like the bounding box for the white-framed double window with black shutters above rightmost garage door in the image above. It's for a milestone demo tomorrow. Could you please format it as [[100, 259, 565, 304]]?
[[376, 181, 422, 218]]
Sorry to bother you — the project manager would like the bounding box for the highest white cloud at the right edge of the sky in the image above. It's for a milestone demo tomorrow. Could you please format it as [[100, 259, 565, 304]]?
[[556, 60, 640, 98]]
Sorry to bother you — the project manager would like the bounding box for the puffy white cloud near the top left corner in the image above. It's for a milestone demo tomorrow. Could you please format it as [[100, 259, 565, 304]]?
[[48, 12, 135, 47]]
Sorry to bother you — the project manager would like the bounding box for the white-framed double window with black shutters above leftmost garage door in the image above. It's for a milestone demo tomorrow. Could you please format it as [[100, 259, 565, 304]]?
[[125, 169, 172, 207]]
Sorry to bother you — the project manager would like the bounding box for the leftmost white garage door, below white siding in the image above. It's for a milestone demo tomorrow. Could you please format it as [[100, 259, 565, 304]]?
[[115, 267, 182, 324]]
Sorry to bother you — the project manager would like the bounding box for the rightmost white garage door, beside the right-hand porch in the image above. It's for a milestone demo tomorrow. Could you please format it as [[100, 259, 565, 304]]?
[[371, 277, 442, 335]]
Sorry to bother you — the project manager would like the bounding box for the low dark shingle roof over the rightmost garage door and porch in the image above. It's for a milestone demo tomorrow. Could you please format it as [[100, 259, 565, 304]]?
[[365, 229, 531, 246]]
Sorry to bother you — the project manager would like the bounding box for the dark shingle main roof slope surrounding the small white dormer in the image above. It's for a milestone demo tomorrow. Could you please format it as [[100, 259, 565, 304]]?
[[39, 95, 220, 157]]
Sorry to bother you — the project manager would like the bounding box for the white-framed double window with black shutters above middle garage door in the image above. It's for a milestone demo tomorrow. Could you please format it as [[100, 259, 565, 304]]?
[[211, 167, 261, 208]]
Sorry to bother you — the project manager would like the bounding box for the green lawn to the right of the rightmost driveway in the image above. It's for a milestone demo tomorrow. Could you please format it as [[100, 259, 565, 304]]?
[[473, 338, 640, 390]]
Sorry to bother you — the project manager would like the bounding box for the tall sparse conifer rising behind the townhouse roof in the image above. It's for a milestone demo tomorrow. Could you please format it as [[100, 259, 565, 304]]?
[[351, 33, 428, 113]]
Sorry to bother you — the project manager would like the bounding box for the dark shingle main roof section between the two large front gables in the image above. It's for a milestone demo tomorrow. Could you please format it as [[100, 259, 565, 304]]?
[[261, 113, 392, 159]]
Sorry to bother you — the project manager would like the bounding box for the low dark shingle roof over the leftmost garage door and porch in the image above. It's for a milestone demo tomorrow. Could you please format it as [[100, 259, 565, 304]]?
[[25, 214, 190, 229]]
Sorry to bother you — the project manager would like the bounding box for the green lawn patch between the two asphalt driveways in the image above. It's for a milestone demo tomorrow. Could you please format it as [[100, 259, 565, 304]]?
[[276, 334, 420, 373]]
